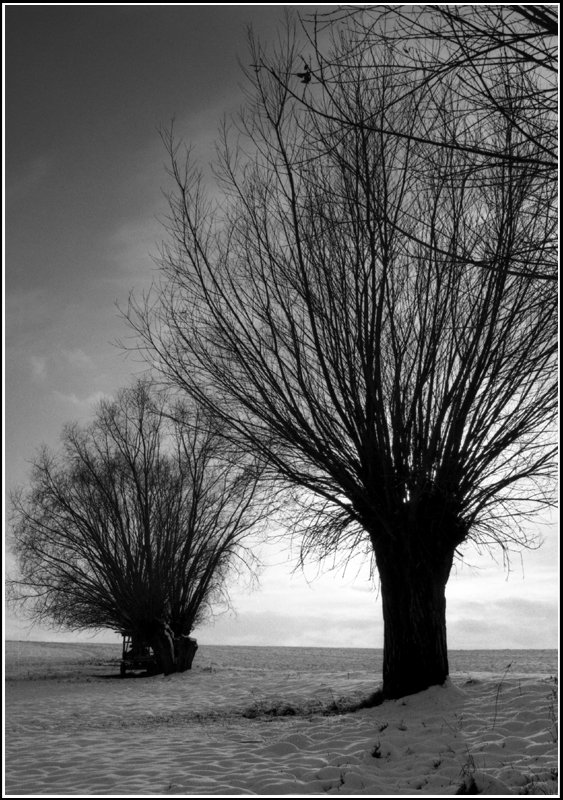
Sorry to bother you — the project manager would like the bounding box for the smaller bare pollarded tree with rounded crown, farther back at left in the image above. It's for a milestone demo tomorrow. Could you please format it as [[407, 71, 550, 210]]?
[[8, 381, 261, 672]]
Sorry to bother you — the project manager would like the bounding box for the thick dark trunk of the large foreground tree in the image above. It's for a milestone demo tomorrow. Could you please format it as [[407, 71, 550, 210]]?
[[376, 537, 453, 698]]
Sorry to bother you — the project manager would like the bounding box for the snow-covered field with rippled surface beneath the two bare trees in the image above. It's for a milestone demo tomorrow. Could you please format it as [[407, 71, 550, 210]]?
[[5, 642, 558, 796]]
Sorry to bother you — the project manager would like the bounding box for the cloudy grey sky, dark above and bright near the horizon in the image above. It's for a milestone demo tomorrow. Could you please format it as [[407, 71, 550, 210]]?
[[4, 5, 558, 648]]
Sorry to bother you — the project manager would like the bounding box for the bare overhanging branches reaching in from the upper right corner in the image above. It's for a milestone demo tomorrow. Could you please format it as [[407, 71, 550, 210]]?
[[258, 4, 559, 283]]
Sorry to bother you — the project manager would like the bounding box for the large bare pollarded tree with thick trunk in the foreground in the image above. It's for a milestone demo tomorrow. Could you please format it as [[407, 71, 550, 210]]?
[[128, 28, 557, 697]]
